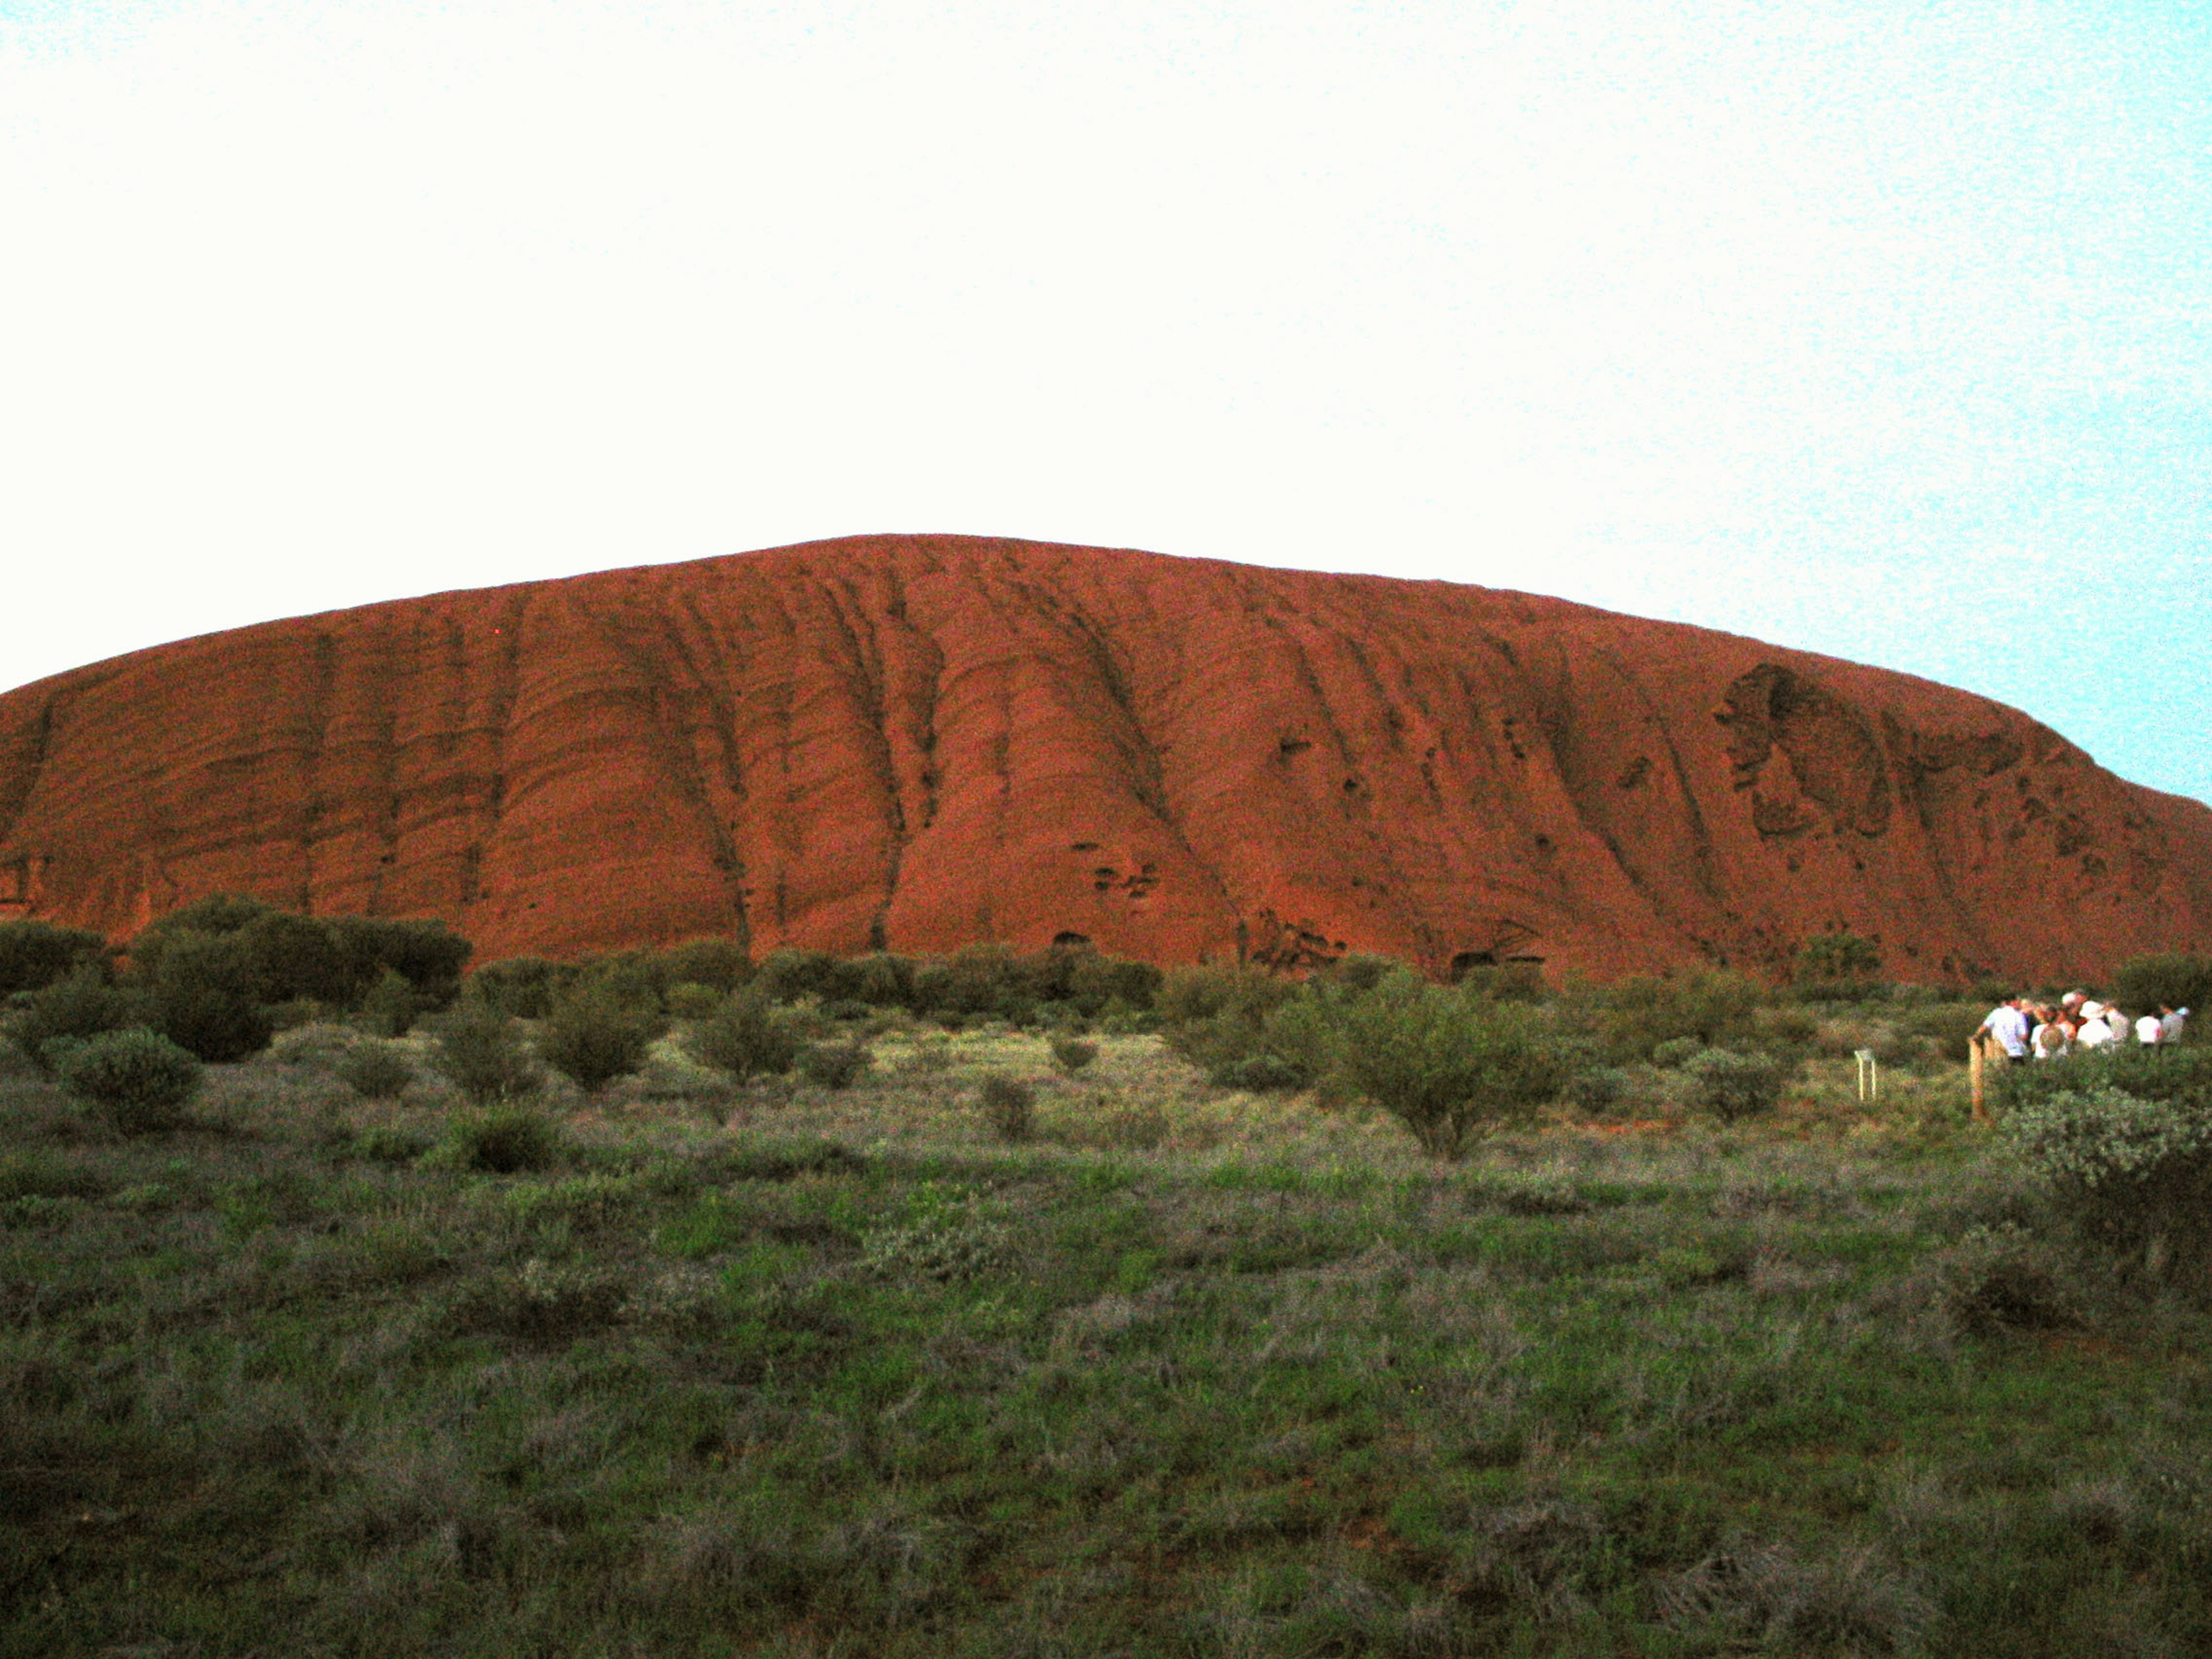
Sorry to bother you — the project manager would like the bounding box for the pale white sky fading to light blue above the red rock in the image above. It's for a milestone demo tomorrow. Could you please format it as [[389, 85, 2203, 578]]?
[[0, 0, 2212, 798]]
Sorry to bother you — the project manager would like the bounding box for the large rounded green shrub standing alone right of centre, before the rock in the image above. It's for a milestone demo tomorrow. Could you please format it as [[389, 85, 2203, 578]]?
[[1343, 971, 1562, 1157]]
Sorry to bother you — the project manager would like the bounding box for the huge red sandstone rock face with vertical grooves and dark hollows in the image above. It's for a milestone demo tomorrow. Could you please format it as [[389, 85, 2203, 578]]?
[[0, 535, 2212, 980]]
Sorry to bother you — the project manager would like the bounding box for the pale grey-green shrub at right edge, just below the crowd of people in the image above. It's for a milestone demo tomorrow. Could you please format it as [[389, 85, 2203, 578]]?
[[2004, 1084, 2212, 1274]]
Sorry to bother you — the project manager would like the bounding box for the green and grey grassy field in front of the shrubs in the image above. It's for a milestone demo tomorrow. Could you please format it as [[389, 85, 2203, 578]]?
[[0, 1031, 2212, 1659]]
